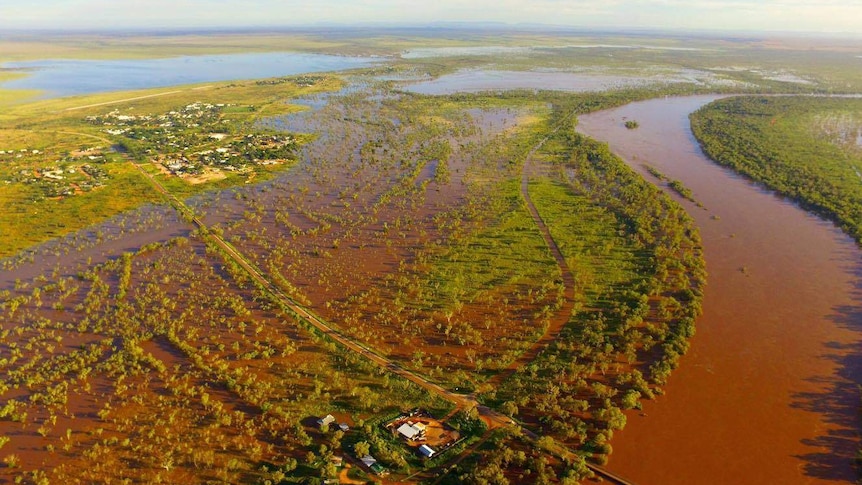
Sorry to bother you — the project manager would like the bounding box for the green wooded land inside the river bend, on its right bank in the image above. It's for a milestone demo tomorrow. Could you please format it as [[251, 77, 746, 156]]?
[[691, 97, 862, 242]]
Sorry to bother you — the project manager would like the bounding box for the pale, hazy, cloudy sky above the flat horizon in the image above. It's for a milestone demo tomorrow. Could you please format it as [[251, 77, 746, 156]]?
[[5, 0, 862, 35]]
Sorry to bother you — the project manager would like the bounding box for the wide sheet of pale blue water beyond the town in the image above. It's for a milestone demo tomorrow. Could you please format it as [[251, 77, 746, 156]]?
[[0, 52, 382, 97]]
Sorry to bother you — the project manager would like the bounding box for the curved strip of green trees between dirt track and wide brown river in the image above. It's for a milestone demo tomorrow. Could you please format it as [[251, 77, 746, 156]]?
[[488, 110, 705, 462]]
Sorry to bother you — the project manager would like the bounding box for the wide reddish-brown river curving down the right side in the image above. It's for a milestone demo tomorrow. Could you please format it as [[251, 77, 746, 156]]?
[[578, 96, 862, 485]]
